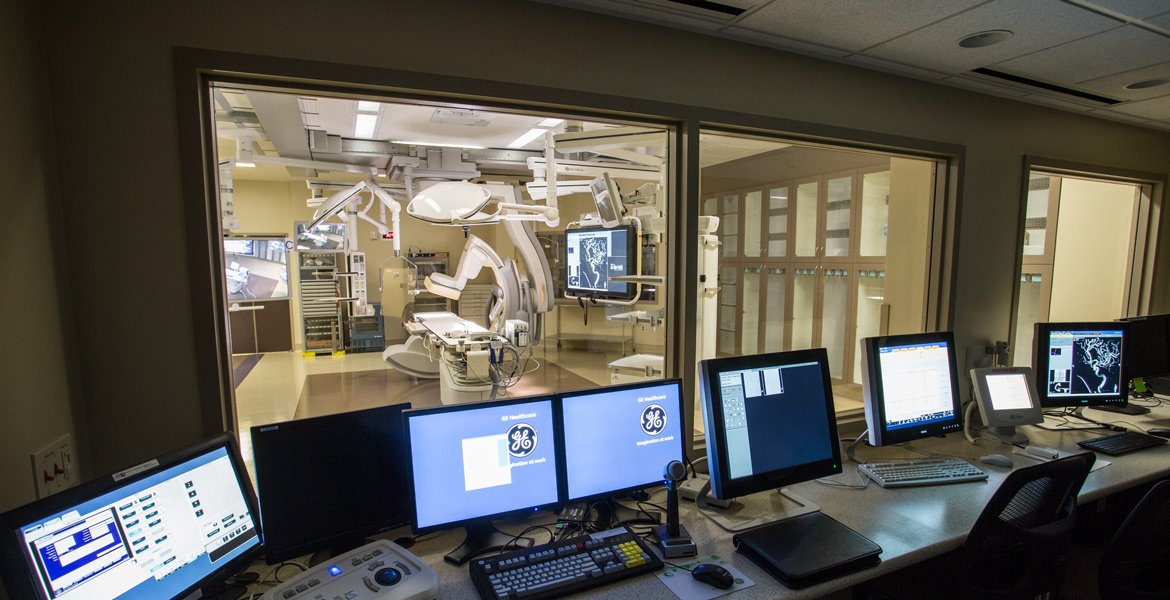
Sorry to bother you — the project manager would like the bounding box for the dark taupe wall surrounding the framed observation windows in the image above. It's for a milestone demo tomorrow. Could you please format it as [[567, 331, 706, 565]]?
[[36, 0, 1170, 477]]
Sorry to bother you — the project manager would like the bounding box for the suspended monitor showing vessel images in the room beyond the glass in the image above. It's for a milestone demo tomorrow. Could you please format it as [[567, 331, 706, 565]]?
[[565, 225, 639, 299]]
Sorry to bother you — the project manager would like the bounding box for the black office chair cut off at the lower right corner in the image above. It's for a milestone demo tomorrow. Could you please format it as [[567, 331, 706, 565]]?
[[1097, 481, 1170, 600]]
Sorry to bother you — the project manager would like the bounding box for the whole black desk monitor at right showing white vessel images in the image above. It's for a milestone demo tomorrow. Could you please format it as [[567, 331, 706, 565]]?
[[1032, 322, 1128, 408]]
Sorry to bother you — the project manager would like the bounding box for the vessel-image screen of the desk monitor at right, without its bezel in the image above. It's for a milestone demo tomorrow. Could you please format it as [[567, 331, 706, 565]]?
[[1047, 330, 1123, 398]]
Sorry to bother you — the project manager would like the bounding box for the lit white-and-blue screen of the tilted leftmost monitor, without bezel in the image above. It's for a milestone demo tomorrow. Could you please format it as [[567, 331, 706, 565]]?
[[10, 447, 260, 600]]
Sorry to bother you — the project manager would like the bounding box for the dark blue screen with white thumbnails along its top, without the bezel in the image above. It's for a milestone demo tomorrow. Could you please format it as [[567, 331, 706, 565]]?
[[718, 363, 837, 478]]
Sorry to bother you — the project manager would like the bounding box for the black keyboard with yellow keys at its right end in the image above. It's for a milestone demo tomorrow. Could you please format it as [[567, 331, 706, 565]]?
[[468, 527, 662, 600]]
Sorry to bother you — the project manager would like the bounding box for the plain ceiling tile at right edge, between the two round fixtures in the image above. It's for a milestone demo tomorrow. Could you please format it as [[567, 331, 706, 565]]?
[[993, 25, 1170, 85]]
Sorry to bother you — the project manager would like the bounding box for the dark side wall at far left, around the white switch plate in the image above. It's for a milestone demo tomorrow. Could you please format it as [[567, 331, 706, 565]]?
[[0, 2, 82, 523]]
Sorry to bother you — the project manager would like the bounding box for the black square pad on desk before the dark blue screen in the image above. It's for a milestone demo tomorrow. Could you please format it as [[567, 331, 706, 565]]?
[[731, 512, 881, 588]]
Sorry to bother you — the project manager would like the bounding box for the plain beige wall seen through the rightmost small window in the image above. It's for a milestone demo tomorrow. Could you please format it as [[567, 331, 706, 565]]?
[[1048, 178, 1136, 320]]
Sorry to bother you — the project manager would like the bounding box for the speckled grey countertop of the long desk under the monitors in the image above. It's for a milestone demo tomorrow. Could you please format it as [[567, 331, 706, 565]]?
[[251, 407, 1170, 600]]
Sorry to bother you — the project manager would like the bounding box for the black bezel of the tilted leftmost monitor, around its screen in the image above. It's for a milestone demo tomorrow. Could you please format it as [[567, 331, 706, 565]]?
[[0, 432, 264, 600]]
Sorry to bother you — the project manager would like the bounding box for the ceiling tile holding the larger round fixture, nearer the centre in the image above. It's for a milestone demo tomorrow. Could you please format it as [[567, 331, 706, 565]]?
[[865, 0, 1122, 74]]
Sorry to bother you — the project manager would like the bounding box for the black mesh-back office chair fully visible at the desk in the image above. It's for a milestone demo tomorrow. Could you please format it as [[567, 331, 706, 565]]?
[[958, 453, 1096, 599]]
